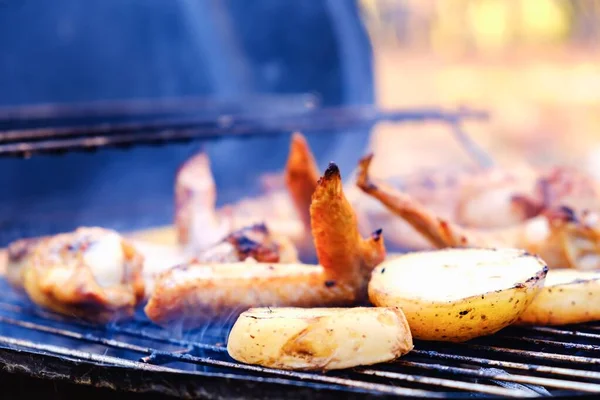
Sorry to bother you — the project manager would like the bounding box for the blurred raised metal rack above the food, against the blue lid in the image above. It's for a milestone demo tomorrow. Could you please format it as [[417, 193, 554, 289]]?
[[0, 96, 488, 158]]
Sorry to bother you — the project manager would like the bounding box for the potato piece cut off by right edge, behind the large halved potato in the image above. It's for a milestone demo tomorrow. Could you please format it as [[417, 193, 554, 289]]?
[[517, 268, 600, 325]]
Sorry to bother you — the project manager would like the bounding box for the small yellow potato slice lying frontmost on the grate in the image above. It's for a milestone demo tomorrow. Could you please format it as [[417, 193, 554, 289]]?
[[227, 307, 413, 370]]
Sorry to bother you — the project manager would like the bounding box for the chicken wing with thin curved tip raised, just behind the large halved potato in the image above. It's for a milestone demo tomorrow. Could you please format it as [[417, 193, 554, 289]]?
[[357, 155, 600, 269]]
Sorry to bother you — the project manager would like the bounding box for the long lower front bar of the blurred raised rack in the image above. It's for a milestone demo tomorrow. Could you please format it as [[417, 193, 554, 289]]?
[[0, 107, 486, 156]]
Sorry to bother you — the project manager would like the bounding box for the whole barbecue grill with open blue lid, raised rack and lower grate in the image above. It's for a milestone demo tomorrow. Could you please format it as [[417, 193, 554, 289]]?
[[0, 0, 600, 399]]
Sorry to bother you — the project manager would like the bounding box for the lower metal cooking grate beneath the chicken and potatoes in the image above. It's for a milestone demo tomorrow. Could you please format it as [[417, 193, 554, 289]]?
[[0, 281, 600, 398]]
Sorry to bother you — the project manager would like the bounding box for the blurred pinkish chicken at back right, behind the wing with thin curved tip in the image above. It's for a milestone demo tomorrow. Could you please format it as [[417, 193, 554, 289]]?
[[353, 160, 600, 249]]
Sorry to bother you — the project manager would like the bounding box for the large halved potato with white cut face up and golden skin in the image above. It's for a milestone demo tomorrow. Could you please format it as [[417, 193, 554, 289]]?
[[369, 248, 548, 342]]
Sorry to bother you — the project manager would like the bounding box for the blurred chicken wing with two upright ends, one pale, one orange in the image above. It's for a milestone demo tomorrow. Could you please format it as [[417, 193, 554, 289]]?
[[175, 133, 319, 259]]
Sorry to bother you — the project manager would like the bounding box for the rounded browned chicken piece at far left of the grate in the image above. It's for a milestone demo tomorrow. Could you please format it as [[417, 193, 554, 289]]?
[[23, 227, 144, 324]]
